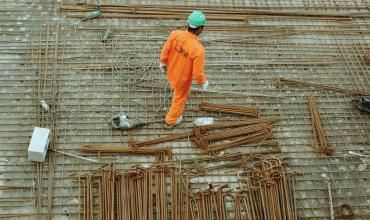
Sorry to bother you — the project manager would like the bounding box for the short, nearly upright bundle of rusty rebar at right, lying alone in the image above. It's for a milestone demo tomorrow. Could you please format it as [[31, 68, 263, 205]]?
[[307, 96, 334, 155]]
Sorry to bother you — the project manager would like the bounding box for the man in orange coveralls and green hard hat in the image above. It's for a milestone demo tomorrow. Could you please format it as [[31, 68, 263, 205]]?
[[159, 11, 208, 128]]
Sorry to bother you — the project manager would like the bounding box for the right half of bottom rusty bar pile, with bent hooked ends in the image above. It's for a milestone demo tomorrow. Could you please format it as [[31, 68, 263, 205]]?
[[184, 154, 298, 220]]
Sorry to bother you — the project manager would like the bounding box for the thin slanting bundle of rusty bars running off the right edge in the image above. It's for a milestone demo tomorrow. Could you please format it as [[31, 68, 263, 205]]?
[[276, 77, 370, 96]]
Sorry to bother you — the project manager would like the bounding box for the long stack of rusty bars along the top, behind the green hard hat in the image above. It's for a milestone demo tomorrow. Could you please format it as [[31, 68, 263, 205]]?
[[59, 4, 369, 20]]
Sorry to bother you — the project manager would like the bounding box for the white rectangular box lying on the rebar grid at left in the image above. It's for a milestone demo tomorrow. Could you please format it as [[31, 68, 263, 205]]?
[[28, 127, 50, 162]]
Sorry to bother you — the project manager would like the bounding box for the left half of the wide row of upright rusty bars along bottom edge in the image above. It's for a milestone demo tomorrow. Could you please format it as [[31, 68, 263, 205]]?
[[78, 164, 184, 220]]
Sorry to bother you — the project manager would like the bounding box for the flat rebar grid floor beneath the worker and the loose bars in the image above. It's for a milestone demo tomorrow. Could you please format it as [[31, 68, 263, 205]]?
[[0, 1, 370, 219]]
